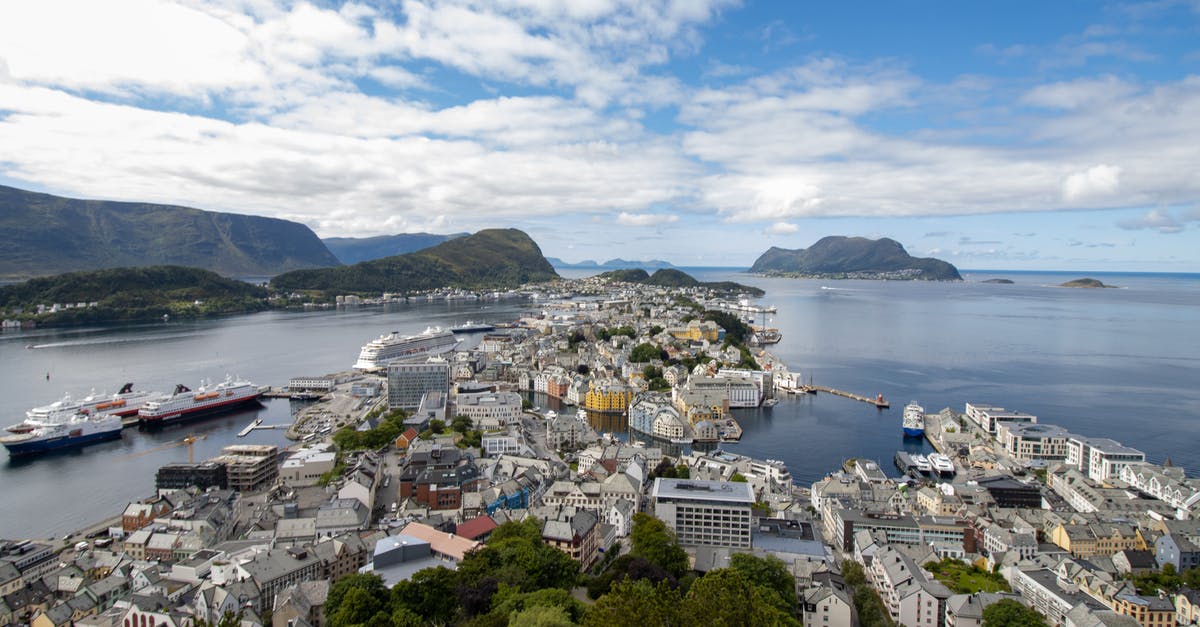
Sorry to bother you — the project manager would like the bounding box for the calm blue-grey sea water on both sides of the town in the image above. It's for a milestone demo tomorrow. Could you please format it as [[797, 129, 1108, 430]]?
[[0, 268, 1200, 537]]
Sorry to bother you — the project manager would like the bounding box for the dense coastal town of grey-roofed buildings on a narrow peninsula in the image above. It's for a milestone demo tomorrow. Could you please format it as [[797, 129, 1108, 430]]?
[[0, 277, 1200, 627]]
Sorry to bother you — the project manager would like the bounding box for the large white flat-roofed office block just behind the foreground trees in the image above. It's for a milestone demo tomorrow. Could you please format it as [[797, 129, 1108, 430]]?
[[652, 478, 755, 548]]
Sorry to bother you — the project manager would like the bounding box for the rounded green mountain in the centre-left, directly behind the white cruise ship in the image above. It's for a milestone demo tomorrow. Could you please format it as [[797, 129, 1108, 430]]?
[[271, 228, 558, 294]]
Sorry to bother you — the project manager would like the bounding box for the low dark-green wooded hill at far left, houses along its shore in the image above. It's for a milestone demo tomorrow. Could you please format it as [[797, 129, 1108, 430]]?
[[0, 265, 266, 324]]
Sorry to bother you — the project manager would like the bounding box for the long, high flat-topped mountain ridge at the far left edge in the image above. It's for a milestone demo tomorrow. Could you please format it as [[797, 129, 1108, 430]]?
[[0, 181, 338, 279]]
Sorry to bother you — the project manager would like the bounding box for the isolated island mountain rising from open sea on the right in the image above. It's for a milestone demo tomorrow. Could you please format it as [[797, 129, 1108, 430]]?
[[750, 235, 962, 281]]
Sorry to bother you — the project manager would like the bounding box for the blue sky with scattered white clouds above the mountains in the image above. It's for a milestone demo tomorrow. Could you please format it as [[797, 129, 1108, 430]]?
[[0, 0, 1200, 273]]
